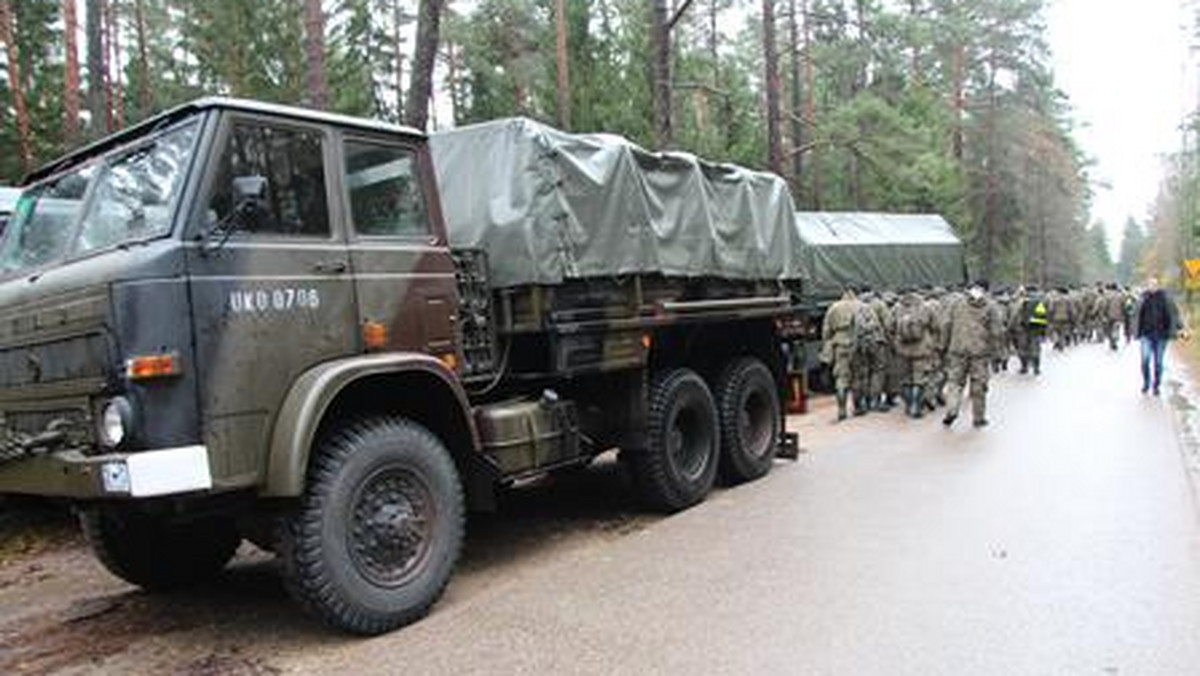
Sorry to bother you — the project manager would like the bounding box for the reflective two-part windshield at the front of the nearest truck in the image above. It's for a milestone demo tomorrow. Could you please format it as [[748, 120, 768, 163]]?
[[0, 122, 198, 274]]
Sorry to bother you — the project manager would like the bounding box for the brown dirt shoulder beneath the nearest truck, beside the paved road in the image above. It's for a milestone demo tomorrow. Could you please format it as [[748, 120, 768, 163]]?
[[0, 457, 658, 676]]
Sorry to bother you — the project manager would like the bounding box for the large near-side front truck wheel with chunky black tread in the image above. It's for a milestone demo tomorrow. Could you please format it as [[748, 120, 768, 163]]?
[[278, 418, 464, 635]]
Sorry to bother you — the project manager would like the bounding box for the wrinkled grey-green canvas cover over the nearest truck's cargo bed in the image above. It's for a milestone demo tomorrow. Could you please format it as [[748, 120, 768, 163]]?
[[430, 118, 802, 287]]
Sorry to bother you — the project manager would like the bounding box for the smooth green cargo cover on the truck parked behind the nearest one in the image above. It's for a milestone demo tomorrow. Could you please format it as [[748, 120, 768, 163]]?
[[796, 211, 966, 297]]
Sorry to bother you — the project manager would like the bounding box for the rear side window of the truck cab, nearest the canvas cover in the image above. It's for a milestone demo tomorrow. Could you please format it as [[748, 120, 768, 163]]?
[[346, 140, 430, 237]]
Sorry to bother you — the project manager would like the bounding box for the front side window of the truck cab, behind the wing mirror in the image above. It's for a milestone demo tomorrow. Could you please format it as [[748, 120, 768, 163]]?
[[209, 122, 330, 237]]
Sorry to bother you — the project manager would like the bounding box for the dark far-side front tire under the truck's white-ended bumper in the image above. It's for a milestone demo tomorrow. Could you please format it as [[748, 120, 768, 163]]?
[[79, 509, 241, 591]]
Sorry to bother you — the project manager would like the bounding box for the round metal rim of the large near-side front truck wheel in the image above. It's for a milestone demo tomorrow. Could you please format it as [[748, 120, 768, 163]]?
[[349, 467, 436, 587]]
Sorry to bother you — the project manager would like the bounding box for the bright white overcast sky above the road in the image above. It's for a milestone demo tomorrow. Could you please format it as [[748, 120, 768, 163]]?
[[1048, 0, 1200, 256]]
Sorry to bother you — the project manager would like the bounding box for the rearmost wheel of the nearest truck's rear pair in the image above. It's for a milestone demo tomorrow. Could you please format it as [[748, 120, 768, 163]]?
[[716, 357, 780, 483]]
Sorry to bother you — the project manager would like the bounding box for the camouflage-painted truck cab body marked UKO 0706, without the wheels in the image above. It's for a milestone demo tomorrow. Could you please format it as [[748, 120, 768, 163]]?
[[0, 100, 472, 499]]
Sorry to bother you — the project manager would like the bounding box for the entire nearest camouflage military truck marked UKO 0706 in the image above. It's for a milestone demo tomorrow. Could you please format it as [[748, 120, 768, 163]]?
[[0, 98, 799, 634]]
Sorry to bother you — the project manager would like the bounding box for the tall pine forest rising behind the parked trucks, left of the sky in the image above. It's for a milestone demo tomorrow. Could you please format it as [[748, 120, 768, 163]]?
[[0, 0, 1123, 286]]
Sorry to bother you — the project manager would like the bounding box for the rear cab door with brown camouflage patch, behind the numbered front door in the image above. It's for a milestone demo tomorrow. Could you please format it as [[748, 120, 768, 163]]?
[[341, 134, 460, 365]]
